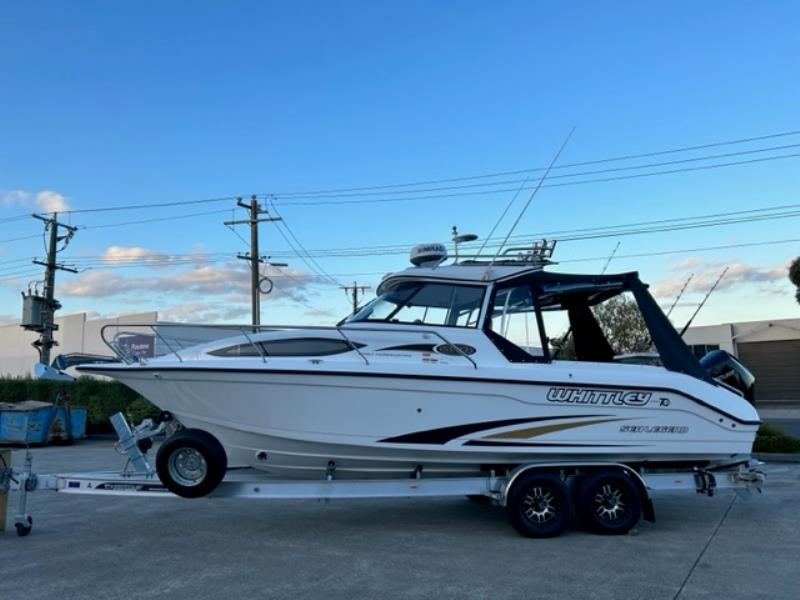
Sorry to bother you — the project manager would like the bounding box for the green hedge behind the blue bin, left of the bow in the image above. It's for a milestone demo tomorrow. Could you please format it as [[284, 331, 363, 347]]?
[[0, 377, 159, 433]]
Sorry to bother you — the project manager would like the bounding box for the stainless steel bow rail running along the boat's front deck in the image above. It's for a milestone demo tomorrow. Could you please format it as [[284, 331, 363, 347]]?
[[100, 323, 478, 369]]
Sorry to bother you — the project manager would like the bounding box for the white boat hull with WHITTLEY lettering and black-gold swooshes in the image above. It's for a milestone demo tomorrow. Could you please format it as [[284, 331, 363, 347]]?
[[97, 361, 757, 478]]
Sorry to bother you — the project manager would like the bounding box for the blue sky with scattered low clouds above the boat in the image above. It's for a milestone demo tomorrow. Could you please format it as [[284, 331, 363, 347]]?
[[0, 1, 800, 324]]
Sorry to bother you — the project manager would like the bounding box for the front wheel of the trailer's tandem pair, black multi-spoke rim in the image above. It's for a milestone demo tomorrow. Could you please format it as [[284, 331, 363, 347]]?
[[506, 471, 572, 538]]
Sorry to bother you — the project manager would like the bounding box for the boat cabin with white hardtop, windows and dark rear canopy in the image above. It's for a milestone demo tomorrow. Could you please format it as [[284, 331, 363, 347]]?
[[344, 263, 709, 380]]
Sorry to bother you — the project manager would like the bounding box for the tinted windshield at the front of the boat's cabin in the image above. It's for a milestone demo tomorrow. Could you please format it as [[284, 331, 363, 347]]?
[[345, 281, 485, 327]]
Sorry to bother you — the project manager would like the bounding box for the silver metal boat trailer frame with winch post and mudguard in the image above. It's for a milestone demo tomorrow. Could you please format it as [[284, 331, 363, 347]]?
[[0, 413, 765, 536]]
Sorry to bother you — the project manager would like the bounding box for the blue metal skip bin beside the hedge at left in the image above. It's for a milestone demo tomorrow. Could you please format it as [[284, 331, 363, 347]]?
[[0, 400, 86, 444]]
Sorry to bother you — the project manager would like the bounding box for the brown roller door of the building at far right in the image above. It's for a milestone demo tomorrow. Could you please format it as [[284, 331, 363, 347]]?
[[736, 340, 800, 402]]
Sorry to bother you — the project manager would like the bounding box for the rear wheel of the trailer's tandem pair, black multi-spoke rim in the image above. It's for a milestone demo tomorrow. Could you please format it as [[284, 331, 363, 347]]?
[[576, 470, 642, 535]]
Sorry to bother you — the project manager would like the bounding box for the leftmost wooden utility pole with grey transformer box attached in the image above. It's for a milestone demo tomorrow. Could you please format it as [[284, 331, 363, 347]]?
[[22, 213, 78, 365]]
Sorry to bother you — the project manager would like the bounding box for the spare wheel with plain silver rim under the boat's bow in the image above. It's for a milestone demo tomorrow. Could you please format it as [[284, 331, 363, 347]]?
[[156, 429, 228, 498]]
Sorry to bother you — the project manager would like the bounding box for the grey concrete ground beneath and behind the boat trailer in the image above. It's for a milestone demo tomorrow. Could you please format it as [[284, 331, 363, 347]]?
[[0, 440, 800, 600]]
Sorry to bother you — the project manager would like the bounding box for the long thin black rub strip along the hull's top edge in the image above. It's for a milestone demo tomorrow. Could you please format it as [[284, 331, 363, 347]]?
[[75, 364, 762, 425]]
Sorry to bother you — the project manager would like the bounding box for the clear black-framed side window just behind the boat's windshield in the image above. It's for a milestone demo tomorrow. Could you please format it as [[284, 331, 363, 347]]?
[[490, 284, 544, 357]]
